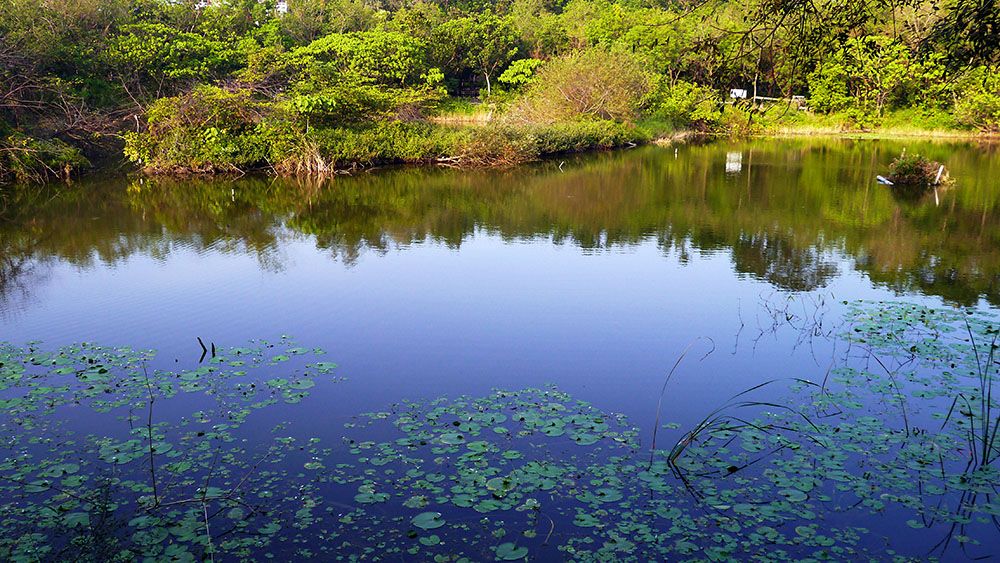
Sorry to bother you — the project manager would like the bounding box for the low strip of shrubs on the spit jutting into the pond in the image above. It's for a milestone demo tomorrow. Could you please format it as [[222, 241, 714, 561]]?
[[125, 86, 645, 174]]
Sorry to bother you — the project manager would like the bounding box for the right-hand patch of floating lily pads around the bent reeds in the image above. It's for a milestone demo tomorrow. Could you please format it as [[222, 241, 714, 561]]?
[[652, 302, 1000, 560]]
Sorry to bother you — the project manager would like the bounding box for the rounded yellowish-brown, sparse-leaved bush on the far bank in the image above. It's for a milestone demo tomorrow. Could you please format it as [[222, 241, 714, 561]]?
[[509, 49, 651, 123]]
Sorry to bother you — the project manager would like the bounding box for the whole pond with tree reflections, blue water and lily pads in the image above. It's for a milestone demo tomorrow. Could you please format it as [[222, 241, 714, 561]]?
[[0, 138, 1000, 562]]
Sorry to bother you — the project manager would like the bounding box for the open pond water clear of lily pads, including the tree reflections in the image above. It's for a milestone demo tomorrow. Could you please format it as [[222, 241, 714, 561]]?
[[0, 140, 1000, 560]]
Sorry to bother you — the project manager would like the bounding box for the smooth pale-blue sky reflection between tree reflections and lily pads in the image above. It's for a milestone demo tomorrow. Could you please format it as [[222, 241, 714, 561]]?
[[2, 231, 952, 431]]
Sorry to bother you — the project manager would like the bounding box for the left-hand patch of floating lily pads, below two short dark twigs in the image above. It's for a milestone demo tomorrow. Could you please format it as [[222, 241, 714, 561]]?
[[0, 337, 336, 562]]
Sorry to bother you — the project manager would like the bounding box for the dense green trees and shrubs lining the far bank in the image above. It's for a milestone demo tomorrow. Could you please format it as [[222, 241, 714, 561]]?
[[0, 0, 1000, 180]]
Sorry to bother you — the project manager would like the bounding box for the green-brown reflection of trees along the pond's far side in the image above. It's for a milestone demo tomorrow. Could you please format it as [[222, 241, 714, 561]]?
[[0, 140, 1000, 309]]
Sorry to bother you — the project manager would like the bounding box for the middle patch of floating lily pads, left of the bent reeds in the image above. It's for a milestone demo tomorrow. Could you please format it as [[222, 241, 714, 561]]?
[[326, 387, 884, 562]]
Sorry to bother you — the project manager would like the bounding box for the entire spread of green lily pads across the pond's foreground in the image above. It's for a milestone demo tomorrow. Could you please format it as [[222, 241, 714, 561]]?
[[0, 303, 1000, 563]]
